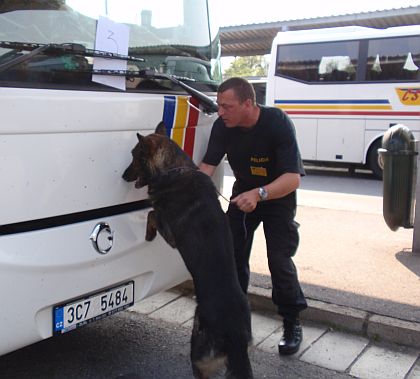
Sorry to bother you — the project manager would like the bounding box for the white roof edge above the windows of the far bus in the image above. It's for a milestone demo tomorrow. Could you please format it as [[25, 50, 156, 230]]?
[[274, 25, 420, 45]]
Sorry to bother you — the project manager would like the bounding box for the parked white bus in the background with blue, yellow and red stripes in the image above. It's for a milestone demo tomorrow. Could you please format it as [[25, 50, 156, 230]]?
[[266, 25, 420, 177]]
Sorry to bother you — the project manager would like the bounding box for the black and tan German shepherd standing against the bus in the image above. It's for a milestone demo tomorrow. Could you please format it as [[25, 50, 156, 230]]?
[[123, 122, 253, 379]]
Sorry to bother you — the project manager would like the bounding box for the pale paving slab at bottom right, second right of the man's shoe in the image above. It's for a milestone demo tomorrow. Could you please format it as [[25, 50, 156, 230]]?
[[350, 346, 418, 379]]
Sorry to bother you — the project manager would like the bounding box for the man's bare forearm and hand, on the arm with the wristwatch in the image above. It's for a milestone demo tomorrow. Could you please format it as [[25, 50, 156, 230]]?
[[231, 172, 300, 212]]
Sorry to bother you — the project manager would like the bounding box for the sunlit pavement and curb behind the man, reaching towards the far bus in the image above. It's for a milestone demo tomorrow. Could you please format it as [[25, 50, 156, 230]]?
[[218, 171, 420, 350]]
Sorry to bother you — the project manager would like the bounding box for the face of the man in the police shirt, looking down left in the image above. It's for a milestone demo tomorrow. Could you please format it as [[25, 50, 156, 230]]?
[[217, 89, 250, 128]]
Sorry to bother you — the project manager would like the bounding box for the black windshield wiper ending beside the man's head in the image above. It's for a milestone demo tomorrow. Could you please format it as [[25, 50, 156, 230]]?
[[90, 70, 219, 113]]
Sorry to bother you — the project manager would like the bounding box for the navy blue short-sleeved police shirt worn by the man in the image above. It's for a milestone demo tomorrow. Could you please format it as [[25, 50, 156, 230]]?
[[203, 105, 305, 208]]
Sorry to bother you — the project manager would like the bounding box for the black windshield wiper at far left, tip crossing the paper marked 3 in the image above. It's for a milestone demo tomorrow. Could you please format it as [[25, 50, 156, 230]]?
[[0, 41, 145, 72]]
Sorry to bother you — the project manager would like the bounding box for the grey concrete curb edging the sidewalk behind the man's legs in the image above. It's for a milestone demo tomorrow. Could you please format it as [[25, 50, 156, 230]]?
[[174, 280, 420, 348]]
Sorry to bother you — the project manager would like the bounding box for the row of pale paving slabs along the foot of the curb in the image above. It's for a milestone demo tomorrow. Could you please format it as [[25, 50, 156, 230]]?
[[130, 291, 420, 379]]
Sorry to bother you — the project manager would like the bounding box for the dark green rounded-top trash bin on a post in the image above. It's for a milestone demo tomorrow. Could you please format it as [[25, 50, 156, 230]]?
[[378, 124, 418, 231]]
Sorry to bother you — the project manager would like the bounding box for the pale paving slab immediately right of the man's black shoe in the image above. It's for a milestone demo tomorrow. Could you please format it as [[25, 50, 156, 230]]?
[[300, 331, 369, 371]]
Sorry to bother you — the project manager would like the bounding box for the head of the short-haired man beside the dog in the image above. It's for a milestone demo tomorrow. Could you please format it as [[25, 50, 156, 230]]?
[[217, 78, 259, 128]]
